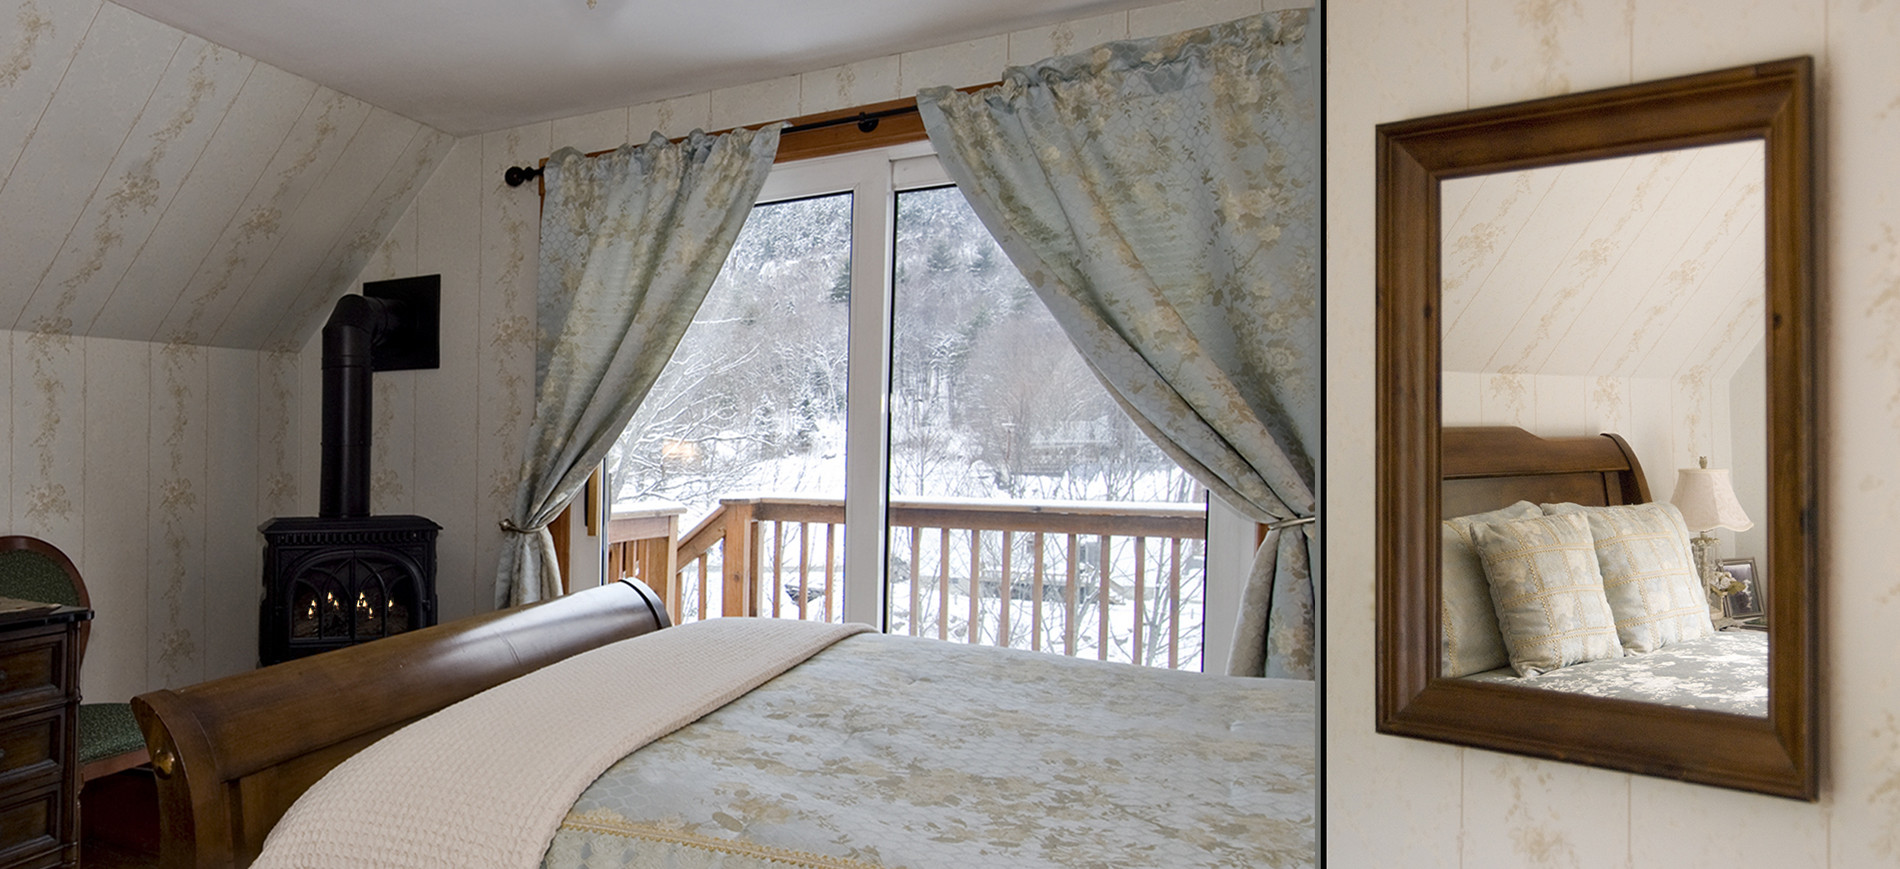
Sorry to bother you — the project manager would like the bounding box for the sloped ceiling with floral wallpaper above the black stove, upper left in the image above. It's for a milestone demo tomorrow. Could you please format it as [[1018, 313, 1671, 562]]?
[[0, 0, 454, 348]]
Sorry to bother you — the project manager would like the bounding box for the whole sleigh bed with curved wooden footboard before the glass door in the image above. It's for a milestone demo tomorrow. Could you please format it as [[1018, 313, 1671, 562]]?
[[135, 584, 1315, 869]]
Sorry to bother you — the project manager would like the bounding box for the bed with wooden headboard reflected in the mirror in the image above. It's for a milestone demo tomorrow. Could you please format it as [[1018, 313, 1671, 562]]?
[[1440, 426, 1767, 717]]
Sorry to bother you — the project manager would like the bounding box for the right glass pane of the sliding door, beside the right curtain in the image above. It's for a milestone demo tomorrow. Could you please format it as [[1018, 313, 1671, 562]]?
[[887, 186, 1207, 669]]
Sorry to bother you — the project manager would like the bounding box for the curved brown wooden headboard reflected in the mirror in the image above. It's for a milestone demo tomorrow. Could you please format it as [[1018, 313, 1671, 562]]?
[[1438, 426, 1649, 519]]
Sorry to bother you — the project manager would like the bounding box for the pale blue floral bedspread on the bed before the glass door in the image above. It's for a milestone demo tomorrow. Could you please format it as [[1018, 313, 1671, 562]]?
[[543, 633, 1315, 869]]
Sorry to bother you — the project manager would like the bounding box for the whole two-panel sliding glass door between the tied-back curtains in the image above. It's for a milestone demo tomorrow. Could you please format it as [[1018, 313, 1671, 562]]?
[[608, 143, 1208, 669]]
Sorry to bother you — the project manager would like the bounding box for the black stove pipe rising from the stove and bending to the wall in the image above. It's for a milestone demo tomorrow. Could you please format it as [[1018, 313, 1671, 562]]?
[[317, 295, 397, 519]]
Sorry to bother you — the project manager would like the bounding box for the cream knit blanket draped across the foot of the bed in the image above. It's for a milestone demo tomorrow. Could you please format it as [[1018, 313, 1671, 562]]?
[[255, 618, 868, 869]]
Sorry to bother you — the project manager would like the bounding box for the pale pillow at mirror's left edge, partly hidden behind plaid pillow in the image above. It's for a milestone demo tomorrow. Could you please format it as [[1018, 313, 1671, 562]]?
[[1438, 500, 1543, 679]]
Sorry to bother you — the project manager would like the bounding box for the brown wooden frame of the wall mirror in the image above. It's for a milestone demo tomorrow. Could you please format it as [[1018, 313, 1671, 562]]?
[[1376, 57, 1820, 801]]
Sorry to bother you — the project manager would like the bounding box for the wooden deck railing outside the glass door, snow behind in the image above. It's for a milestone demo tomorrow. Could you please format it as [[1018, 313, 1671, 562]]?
[[608, 498, 1207, 669]]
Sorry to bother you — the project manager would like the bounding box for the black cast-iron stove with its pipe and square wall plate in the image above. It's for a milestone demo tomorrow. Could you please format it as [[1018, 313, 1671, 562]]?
[[257, 276, 441, 666]]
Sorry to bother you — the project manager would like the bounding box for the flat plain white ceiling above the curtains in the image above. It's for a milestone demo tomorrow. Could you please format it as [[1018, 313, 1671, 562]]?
[[116, 0, 1146, 135]]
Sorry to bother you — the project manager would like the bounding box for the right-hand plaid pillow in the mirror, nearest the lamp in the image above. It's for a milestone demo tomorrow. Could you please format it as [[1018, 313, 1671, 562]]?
[[1545, 504, 1716, 654]]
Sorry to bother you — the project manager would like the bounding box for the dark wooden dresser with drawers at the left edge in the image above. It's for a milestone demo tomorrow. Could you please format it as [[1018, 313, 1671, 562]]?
[[0, 597, 93, 869]]
